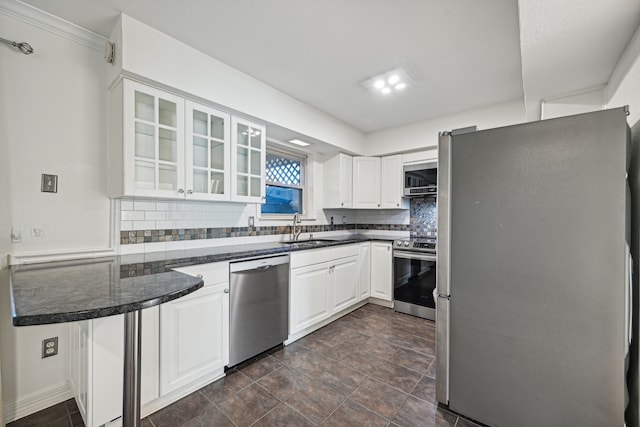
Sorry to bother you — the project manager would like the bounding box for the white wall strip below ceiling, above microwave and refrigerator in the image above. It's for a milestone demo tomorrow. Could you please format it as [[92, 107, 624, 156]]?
[[365, 100, 526, 156]]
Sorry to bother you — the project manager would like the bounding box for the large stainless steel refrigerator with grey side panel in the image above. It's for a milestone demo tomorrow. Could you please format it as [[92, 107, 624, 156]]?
[[436, 108, 632, 427]]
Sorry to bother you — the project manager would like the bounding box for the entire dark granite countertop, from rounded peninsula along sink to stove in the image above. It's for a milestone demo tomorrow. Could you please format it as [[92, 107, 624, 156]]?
[[10, 234, 404, 326]]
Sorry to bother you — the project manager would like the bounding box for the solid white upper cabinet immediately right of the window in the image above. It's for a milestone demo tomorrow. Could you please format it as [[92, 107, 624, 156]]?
[[323, 153, 353, 208]]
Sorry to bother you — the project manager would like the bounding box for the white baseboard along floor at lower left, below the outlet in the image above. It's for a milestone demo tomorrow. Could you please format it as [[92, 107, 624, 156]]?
[[3, 381, 73, 423]]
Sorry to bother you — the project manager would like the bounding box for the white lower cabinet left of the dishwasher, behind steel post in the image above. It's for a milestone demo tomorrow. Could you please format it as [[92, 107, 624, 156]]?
[[70, 262, 229, 427]]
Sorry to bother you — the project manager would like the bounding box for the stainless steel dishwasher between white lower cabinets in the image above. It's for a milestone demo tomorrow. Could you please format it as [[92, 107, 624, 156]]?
[[228, 255, 289, 366]]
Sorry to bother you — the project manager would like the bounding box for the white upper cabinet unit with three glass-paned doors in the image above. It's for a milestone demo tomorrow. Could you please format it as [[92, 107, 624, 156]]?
[[107, 79, 266, 203]]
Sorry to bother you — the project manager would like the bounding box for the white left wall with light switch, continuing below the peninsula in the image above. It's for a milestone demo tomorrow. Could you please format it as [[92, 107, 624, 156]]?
[[0, 2, 110, 423]]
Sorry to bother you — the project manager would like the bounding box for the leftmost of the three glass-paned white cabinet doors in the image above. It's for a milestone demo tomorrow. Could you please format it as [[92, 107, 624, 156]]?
[[123, 80, 185, 198]]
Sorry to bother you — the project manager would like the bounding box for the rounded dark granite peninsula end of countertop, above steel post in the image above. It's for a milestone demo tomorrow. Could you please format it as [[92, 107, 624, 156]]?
[[10, 257, 204, 326]]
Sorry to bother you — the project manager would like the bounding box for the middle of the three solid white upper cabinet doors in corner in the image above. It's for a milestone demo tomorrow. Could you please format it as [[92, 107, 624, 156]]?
[[353, 157, 380, 209]]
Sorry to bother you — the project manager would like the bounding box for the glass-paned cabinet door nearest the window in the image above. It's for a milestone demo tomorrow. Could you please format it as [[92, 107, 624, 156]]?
[[231, 117, 266, 203]]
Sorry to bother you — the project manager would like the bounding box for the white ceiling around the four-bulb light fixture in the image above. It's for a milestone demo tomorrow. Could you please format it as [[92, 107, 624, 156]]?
[[12, 0, 640, 132]]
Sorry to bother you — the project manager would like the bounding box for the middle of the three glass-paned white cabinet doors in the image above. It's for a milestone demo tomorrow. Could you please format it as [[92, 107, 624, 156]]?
[[185, 101, 231, 201]]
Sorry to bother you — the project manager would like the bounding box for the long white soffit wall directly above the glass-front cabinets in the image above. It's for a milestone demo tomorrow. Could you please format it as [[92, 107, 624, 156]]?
[[114, 15, 364, 158]]
